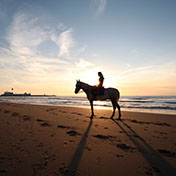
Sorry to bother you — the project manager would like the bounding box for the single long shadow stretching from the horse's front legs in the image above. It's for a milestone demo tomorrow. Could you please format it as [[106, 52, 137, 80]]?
[[66, 119, 93, 176]]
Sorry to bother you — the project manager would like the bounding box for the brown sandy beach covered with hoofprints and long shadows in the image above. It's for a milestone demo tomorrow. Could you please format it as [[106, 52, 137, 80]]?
[[0, 103, 176, 176]]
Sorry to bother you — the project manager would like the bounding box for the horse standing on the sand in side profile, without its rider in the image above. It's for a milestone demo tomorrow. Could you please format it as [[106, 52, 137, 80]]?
[[75, 80, 121, 120]]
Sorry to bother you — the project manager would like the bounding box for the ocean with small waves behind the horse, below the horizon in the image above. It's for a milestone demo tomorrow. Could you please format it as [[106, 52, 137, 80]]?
[[0, 96, 176, 115]]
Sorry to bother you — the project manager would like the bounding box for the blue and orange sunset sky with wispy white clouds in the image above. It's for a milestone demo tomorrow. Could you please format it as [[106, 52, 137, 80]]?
[[0, 0, 176, 96]]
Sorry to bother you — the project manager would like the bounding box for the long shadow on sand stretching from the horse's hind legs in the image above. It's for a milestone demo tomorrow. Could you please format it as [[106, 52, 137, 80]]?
[[112, 120, 176, 176]]
